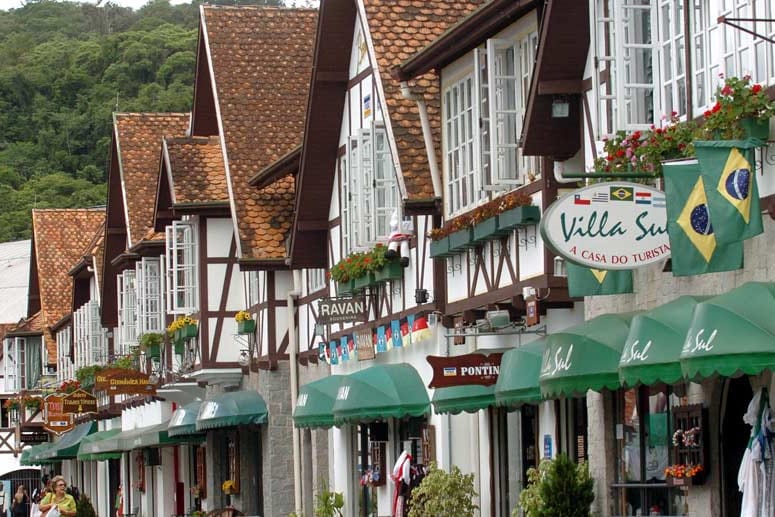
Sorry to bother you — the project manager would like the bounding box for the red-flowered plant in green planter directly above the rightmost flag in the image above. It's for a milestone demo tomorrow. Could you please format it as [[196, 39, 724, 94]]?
[[702, 74, 775, 140]]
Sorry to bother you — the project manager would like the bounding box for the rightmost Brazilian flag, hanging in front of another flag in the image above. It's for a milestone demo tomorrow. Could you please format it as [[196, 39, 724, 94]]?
[[694, 140, 763, 244]]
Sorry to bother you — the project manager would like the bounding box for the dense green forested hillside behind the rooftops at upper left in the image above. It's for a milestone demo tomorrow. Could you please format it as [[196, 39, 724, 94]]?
[[0, 0, 280, 242]]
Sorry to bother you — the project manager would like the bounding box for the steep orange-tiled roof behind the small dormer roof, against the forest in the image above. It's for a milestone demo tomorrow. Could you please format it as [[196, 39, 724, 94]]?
[[113, 113, 190, 248]]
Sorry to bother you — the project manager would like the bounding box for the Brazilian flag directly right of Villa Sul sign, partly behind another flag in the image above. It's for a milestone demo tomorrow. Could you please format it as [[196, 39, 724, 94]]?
[[662, 160, 743, 276]]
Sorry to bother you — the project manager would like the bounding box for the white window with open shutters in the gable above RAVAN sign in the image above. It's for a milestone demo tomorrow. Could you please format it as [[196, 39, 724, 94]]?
[[339, 124, 398, 253]]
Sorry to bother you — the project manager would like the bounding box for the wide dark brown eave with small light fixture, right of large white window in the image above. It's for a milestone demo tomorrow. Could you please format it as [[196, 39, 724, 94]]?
[[521, 0, 590, 161]]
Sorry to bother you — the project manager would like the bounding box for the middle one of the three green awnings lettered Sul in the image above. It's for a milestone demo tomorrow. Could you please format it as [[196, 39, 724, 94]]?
[[619, 296, 707, 386]]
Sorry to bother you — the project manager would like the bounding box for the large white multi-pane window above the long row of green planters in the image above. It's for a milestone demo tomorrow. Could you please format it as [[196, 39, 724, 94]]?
[[442, 32, 538, 215]]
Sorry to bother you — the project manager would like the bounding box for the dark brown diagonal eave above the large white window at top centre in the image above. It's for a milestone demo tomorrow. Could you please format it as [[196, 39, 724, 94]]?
[[390, 0, 540, 81]]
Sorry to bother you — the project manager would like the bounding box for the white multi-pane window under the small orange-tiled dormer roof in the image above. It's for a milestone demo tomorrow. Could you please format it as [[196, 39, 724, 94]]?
[[165, 220, 199, 314]]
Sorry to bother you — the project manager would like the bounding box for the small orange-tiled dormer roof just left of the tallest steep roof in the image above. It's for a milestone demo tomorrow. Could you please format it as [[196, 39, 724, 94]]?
[[163, 136, 229, 204]]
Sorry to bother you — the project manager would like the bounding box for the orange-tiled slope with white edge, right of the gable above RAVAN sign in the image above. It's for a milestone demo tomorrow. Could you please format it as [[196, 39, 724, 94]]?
[[362, 0, 485, 201]]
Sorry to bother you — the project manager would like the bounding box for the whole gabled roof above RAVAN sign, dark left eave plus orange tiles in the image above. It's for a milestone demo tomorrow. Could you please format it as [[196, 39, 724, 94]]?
[[291, 0, 484, 267]]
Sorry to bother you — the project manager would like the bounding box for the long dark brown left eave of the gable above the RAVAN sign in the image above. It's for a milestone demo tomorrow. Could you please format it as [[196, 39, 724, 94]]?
[[288, 0, 356, 268]]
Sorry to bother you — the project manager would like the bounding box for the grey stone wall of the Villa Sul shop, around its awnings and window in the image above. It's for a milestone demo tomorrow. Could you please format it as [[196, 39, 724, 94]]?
[[584, 215, 775, 517]]
